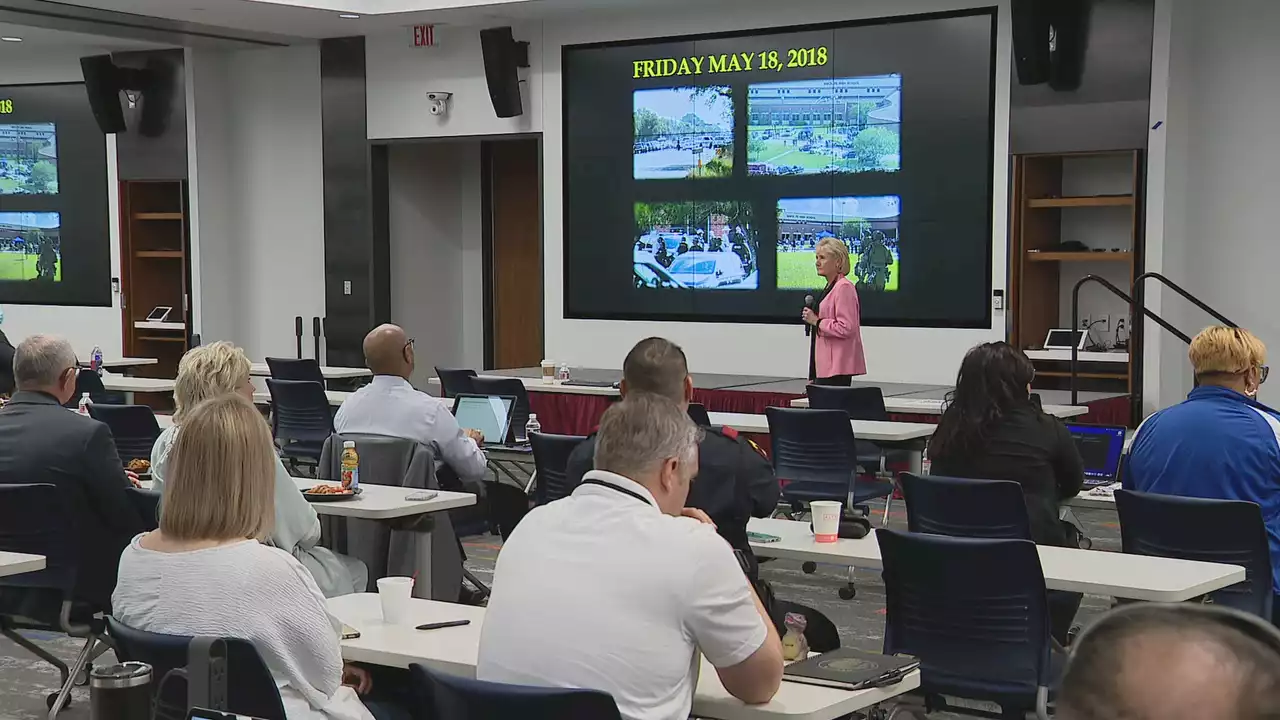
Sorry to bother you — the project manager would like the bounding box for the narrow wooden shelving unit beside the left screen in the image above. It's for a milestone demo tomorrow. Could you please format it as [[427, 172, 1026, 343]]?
[[120, 181, 191, 409]]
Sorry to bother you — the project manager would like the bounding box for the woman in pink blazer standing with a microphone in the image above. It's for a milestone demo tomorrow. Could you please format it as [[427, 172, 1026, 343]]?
[[801, 237, 867, 387]]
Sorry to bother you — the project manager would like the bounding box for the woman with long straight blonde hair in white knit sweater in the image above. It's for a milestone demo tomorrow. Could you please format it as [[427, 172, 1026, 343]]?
[[111, 395, 372, 720]]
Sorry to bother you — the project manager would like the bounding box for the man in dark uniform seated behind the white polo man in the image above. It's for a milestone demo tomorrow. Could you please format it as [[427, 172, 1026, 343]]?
[[566, 337, 781, 575]]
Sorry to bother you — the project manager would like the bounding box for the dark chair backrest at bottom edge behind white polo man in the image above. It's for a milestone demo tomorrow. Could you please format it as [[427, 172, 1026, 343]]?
[[408, 662, 620, 720]]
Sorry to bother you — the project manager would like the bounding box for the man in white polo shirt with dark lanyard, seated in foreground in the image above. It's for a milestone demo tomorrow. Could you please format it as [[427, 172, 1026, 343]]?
[[476, 393, 782, 720]]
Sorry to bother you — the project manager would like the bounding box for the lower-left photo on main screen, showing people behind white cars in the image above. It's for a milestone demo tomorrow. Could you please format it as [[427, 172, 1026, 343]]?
[[632, 201, 760, 290]]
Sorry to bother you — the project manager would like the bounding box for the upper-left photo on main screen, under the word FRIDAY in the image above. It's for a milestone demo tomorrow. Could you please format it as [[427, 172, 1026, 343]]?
[[632, 86, 733, 179]]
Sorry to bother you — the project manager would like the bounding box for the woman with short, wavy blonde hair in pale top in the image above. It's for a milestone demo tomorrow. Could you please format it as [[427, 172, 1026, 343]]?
[[151, 342, 369, 597]]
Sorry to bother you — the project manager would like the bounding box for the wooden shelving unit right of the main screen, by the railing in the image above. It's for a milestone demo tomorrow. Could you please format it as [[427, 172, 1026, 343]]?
[[1009, 150, 1143, 409]]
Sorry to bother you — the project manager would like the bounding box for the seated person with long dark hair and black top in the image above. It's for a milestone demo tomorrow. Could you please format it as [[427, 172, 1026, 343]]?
[[929, 342, 1084, 643]]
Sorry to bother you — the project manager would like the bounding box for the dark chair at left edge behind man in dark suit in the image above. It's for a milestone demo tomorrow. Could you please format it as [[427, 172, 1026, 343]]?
[[0, 484, 106, 717]]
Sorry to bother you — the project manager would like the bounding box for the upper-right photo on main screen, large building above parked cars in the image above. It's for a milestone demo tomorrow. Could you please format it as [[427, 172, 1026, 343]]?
[[746, 74, 902, 176]]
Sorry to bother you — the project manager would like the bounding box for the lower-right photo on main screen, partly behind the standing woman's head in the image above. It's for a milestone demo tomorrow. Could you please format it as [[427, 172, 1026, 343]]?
[[777, 195, 901, 292]]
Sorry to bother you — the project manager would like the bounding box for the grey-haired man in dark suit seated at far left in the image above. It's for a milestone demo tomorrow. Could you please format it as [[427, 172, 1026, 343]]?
[[0, 336, 145, 607]]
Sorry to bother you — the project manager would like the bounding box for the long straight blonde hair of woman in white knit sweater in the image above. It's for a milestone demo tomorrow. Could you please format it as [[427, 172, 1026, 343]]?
[[160, 395, 275, 541]]
